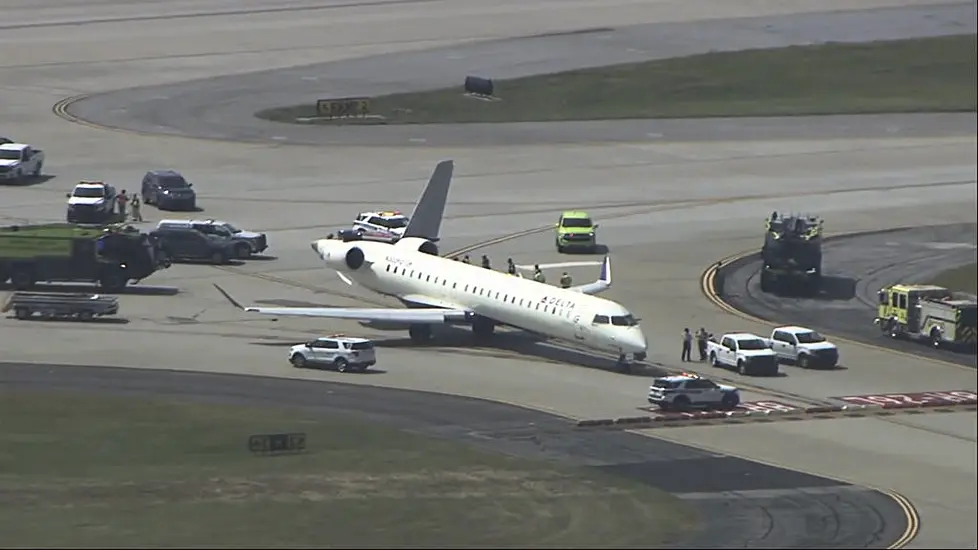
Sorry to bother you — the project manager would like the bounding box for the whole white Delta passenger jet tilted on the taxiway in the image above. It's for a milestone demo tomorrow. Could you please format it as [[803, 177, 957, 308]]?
[[214, 161, 648, 368]]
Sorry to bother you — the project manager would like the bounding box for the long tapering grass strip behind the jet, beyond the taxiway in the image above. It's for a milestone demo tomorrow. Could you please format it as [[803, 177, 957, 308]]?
[[256, 34, 976, 124]]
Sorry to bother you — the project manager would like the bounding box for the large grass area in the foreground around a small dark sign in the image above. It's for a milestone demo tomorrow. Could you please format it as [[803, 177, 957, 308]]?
[[0, 389, 695, 548]]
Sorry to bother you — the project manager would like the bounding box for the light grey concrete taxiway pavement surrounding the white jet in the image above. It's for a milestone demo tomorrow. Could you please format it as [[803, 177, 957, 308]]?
[[0, 0, 978, 547]]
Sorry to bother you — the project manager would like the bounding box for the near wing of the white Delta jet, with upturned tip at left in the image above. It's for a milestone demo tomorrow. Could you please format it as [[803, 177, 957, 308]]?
[[214, 284, 469, 324]]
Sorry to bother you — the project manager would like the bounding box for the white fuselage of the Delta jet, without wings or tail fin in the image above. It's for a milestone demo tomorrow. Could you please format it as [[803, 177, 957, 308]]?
[[313, 239, 647, 359]]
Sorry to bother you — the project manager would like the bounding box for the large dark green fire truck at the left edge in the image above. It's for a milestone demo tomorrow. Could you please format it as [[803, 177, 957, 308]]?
[[0, 223, 170, 292]]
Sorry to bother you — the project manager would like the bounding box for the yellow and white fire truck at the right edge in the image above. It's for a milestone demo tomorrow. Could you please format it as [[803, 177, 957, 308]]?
[[874, 285, 978, 347]]
